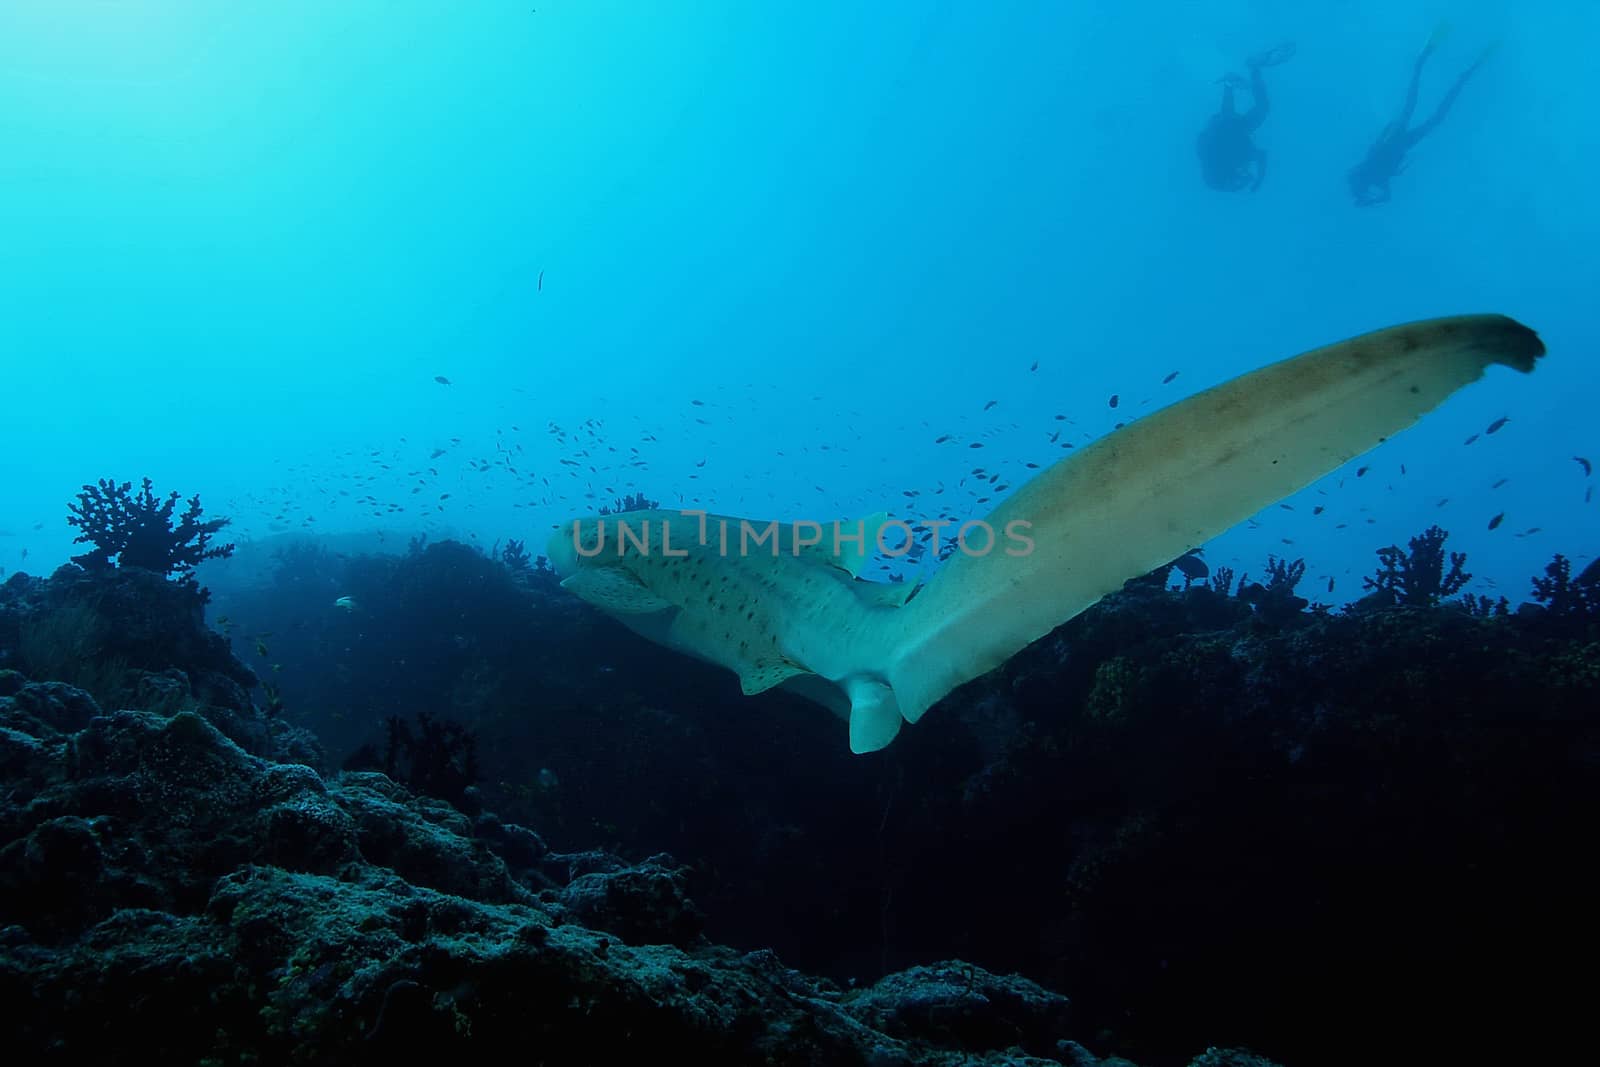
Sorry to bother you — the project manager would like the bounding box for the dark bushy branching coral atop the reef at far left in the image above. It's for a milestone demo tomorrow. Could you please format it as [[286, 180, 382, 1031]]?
[[67, 478, 234, 581]]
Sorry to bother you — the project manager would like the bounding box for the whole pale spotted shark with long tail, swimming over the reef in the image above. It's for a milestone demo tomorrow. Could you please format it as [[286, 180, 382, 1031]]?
[[547, 314, 1546, 753]]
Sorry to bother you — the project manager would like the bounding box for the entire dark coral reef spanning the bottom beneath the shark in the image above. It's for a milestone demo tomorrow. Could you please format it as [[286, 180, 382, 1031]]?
[[0, 536, 1600, 1067]]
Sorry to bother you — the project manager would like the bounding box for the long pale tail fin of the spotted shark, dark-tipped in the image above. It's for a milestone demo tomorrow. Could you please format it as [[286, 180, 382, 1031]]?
[[885, 308, 1544, 721]]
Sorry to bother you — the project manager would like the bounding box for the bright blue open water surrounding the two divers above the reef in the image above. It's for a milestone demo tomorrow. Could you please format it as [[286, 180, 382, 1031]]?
[[0, 0, 1600, 603]]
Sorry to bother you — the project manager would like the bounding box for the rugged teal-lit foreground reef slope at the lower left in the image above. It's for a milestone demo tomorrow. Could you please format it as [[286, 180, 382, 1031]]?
[[0, 677, 1164, 1067]]
